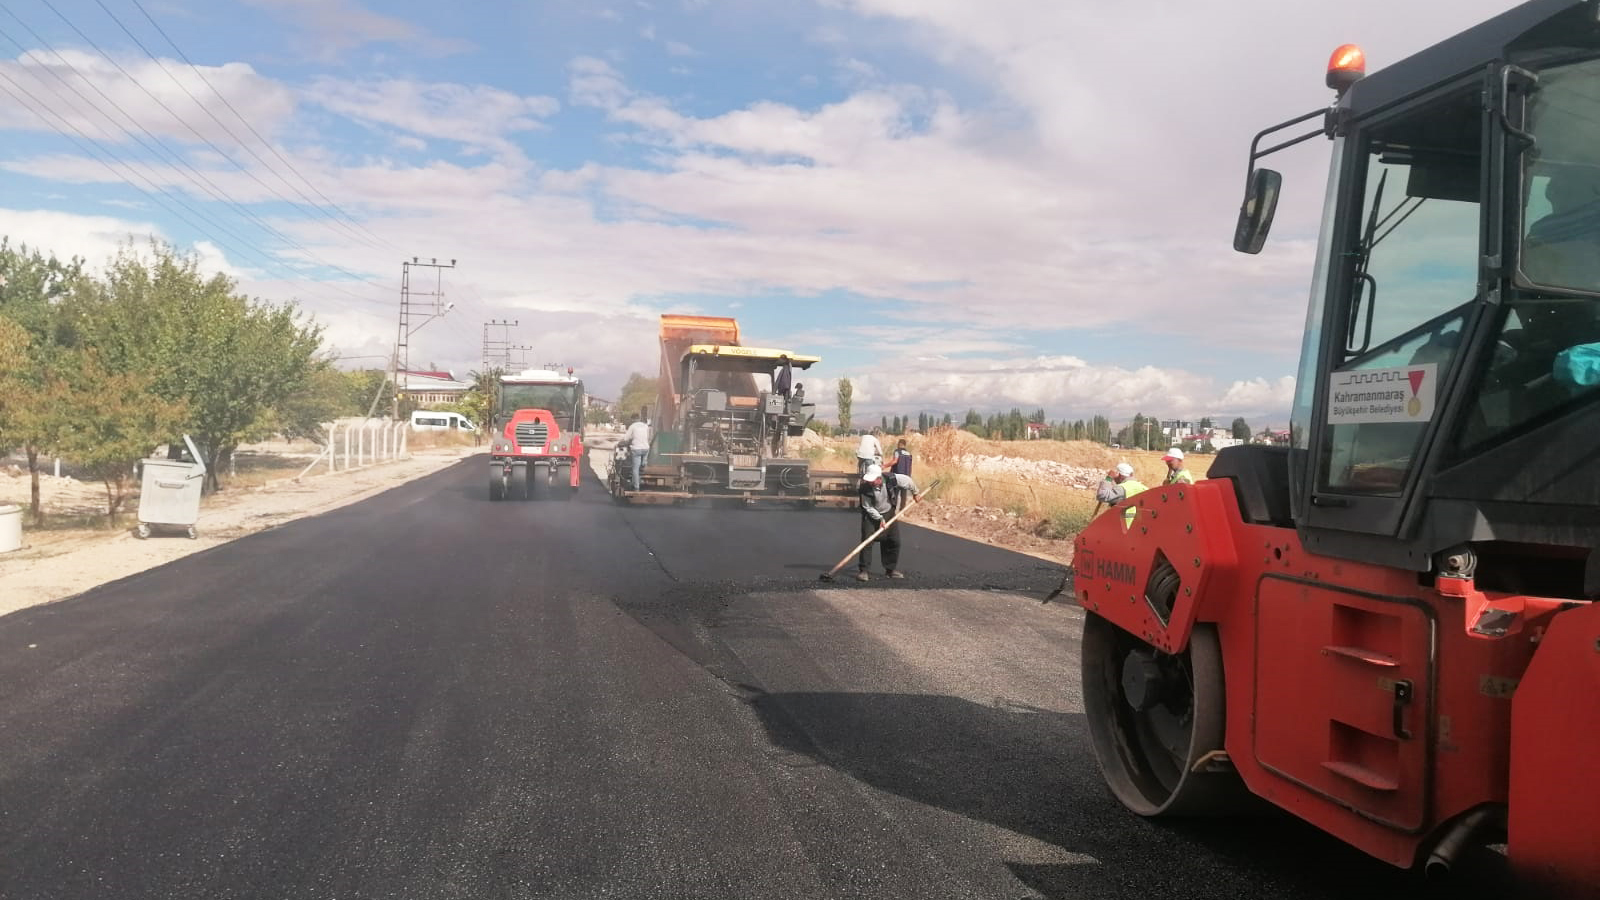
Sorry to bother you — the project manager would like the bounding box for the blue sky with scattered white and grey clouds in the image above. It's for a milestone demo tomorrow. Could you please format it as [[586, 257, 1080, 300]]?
[[0, 0, 1506, 421]]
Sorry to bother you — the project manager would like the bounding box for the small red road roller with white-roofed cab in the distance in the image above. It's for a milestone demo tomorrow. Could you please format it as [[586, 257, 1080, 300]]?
[[490, 368, 587, 501]]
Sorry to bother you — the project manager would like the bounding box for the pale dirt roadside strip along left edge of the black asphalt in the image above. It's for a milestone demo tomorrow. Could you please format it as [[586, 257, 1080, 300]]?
[[0, 442, 483, 615]]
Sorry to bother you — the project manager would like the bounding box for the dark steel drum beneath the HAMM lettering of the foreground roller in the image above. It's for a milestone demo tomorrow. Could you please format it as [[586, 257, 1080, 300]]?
[[1082, 613, 1253, 817]]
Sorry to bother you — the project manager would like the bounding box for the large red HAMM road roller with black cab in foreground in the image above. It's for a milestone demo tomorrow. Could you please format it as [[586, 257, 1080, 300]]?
[[1072, 0, 1600, 897]]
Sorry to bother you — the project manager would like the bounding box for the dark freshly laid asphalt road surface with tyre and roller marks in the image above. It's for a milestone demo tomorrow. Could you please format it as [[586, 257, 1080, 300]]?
[[0, 460, 1465, 900]]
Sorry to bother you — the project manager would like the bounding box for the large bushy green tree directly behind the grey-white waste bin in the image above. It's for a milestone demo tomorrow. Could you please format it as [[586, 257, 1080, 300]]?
[[72, 243, 322, 490]]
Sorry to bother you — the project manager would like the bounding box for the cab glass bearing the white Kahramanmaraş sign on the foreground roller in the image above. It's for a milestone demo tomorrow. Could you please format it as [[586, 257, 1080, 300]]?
[[1320, 93, 1482, 495]]
